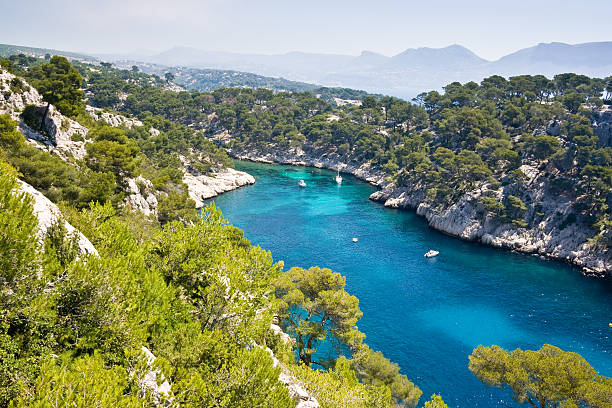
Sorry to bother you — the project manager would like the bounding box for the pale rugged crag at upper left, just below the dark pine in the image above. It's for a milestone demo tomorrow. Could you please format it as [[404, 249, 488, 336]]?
[[0, 68, 88, 160]]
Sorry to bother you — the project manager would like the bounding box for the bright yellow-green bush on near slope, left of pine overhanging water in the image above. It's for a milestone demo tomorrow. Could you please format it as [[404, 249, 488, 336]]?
[[150, 204, 280, 341]]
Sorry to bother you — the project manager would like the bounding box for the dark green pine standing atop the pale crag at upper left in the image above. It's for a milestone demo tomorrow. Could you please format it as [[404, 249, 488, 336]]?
[[28, 55, 83, 131]]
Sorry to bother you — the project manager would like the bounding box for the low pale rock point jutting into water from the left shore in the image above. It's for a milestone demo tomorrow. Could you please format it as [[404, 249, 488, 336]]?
[[183, 168, 255, 208]]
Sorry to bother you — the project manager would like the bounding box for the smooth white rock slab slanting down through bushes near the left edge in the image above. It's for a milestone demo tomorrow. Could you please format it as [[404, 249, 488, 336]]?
[[19, 180, 98, 256]]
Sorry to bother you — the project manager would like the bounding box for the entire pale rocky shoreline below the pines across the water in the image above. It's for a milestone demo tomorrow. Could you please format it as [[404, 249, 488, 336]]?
[[228, 148, 612, 277]]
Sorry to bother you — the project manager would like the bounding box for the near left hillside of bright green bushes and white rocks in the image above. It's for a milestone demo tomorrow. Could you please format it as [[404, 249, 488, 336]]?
[[0, 56, 428, 407]]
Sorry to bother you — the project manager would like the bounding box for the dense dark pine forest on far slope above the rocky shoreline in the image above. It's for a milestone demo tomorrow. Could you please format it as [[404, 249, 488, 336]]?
[[81, 67, 612, 248]]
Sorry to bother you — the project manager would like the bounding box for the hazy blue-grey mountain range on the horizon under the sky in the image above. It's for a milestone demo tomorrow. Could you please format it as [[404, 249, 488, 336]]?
[[0, 41, 612, 99]]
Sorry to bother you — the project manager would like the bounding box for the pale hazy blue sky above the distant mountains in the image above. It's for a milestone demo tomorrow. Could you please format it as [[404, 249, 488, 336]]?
[[0, 0, 612, 59]]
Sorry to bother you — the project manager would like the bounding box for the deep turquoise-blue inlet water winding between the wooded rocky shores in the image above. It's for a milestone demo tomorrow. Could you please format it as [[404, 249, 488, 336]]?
[[207, 162, 612, 408]]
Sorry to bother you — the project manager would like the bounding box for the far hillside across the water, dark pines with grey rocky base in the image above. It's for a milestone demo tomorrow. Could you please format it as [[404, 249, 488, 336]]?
[[62, 55, 612, 275]]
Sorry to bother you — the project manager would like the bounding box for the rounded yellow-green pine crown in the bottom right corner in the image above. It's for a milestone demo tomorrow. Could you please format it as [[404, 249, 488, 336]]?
[[469, 344, 612, 408]]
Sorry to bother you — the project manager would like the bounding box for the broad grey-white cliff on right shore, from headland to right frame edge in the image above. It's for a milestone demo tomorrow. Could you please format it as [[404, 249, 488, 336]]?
[[370, 166, 612, 276]]
